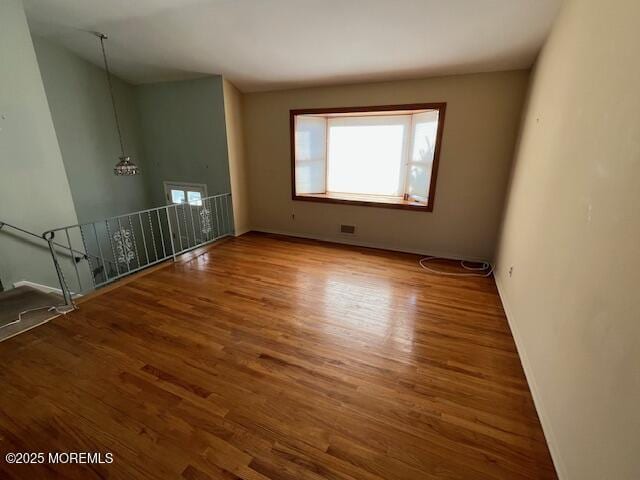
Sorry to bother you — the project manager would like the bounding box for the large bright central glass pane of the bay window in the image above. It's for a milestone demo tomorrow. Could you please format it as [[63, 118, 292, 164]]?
[[327, 116, 410, 196]]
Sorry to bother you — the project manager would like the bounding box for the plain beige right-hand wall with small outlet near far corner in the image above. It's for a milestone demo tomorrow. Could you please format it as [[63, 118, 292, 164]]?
[[496, 0, 640, 480]]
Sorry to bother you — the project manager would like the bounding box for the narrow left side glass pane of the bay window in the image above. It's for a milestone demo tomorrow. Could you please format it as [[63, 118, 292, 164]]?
[[295, 115, 327, 194]]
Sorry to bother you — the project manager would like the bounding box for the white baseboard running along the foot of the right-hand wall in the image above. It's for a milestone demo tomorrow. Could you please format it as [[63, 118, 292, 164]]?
[[494, 275, 569, 480]]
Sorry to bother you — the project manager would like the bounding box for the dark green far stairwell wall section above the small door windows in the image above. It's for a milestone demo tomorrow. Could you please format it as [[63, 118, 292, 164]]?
[[136, 76, 230, 205]]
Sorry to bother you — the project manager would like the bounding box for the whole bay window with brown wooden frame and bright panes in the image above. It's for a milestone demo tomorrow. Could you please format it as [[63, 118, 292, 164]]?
[[291, 104, 445, 211]]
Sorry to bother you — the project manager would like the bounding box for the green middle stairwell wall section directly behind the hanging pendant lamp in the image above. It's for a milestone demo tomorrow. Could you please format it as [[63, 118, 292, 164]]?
[[33, 34, 153, 222]]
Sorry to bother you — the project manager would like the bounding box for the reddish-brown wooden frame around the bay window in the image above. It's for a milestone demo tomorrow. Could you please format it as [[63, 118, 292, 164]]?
[[289, 102, 447, 212]]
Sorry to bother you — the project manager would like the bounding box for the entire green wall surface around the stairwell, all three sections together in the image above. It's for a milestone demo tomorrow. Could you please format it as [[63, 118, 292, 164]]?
[[0, 5, 230, 289]]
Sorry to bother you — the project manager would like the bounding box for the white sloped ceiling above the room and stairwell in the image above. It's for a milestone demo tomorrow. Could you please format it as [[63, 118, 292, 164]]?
[[24, 0, 562, 91]]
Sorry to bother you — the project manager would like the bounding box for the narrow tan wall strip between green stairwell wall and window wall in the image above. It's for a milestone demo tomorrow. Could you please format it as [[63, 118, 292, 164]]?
[[222, 80, 250, 235]]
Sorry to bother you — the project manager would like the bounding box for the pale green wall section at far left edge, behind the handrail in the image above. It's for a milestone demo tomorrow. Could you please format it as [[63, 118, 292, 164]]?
[[0, 0, 82, 288]]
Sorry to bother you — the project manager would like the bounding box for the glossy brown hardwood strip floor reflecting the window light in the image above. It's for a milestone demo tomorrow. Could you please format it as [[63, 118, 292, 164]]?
[[0, 233, 556, 480]]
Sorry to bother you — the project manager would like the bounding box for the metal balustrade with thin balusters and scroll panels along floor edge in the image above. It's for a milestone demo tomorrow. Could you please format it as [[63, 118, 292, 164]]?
[[42, 193, 234, 307]]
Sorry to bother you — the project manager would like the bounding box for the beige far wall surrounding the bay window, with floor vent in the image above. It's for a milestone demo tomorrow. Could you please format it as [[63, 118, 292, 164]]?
[[244, 71, 529, 259]]
